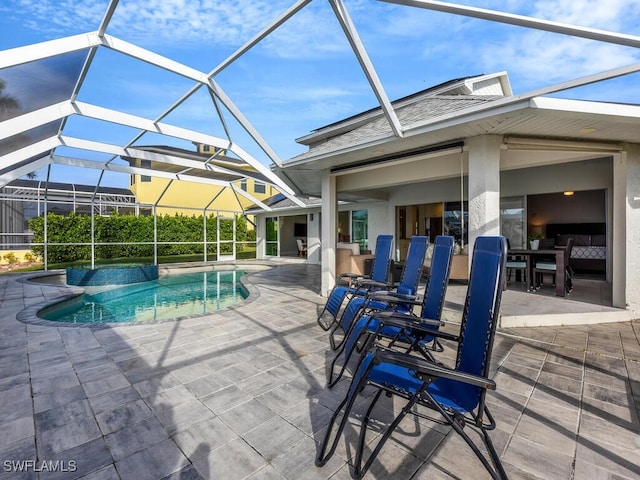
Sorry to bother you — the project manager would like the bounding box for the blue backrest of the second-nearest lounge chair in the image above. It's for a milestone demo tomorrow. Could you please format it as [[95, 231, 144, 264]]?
[[421, 235, 453, 320]]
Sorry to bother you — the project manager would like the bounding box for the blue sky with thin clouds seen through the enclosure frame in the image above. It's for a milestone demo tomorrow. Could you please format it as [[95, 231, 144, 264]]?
[[0, 0, 640, 186]]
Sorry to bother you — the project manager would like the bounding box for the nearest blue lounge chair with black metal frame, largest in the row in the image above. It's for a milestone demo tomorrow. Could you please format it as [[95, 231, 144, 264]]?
[[315, 237, 507, 479]]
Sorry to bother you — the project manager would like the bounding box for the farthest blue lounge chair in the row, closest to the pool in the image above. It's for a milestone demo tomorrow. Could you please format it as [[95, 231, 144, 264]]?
[[317, 235, 393, 330]]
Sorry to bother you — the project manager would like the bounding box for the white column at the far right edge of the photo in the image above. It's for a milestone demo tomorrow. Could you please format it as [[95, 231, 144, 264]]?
[[611, 144, 640, 312]]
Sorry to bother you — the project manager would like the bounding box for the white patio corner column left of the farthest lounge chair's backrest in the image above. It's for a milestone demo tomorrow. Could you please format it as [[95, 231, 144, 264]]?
[[320, 170, 338, 295]]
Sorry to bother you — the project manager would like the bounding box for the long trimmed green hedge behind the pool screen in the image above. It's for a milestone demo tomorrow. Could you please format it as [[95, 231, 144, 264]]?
[[29, 213, 256, 263]]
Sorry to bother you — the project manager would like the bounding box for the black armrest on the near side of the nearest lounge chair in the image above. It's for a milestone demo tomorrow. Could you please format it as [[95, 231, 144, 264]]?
[[374, 350, 496, 390]]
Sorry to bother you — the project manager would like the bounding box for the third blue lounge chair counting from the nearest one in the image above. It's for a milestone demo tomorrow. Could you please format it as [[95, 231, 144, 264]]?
[[329, 235, 429, 350]]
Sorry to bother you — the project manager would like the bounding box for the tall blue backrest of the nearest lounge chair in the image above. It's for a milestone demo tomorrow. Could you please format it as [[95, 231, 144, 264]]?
[[454, 236, 507, 410]]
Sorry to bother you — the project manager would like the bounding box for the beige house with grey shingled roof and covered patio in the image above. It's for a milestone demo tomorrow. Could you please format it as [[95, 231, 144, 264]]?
[[258, 72, 640, 318]]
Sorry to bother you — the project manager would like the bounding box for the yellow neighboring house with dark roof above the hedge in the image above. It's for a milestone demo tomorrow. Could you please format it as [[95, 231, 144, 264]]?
[[122, 144, 278, 215]]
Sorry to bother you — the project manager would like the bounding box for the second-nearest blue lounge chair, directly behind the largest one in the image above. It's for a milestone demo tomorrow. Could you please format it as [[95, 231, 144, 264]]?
[[327, 235, 454, 388]]
